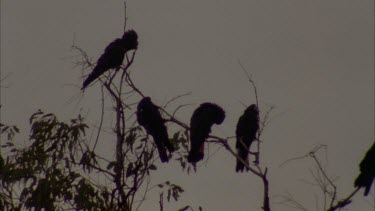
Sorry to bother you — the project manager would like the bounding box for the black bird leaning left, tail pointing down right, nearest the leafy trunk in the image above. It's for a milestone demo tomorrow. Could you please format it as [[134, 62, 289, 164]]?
[[137, 97, 175, 163]]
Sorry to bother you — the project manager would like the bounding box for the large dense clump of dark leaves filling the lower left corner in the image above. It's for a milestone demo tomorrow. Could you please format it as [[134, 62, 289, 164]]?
[[0, 111, 106, 210]]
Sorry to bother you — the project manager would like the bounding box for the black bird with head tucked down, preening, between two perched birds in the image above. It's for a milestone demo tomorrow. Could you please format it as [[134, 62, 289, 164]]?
[[188, 103, 225, 163]]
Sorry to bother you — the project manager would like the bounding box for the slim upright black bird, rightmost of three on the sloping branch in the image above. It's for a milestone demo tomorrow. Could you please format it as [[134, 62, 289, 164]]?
[[236, 104, 259, 172]]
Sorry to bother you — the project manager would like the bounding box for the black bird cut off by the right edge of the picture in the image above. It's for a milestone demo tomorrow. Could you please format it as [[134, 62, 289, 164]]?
[[354, 142, 375, 196]]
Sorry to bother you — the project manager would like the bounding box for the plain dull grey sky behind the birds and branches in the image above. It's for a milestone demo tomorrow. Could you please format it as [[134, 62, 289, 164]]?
[[1, 0, 374, 211]]
